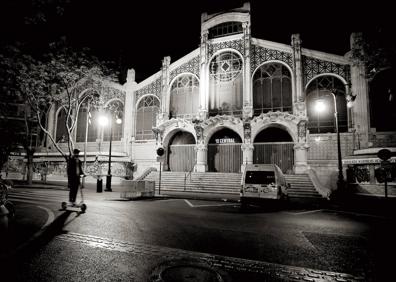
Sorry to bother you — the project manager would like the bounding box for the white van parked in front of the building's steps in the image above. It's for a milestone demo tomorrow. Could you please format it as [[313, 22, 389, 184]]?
[[241, 164, 288, 204]]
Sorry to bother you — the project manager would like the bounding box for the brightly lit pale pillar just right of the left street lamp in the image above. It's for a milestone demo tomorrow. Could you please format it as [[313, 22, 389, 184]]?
[[123, 69, 137, 156]]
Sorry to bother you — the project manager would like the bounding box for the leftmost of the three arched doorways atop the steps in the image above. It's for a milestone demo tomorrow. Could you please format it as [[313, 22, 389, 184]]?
[[168, 131, 196, 171]]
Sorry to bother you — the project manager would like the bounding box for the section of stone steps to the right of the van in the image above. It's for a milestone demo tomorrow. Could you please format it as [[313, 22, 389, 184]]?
[[285, 174, 323, 199]]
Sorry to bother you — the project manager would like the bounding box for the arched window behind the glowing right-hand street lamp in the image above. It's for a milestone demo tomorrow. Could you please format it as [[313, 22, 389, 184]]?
[[306, 75, 348, 133]]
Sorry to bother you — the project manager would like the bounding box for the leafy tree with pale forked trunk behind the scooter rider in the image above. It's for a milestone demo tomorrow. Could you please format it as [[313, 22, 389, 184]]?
[[3, 39, 117, 185]]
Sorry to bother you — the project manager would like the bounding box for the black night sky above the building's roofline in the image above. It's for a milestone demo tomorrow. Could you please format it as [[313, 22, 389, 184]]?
[[0, 0, 396, 81]]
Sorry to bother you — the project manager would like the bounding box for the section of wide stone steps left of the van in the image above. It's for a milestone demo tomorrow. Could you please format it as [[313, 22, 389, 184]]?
[[144, 171, 242, 195]]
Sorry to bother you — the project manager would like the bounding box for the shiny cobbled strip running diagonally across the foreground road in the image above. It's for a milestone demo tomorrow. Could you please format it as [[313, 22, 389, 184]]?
[[56, 232, 365, 282]]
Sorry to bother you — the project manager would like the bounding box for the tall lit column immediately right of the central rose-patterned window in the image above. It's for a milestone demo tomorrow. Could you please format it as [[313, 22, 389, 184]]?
[[243, 22, 253, 119]]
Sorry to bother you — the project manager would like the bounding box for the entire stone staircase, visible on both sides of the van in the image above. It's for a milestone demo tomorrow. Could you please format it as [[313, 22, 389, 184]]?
[[144, 171, 323, 200]]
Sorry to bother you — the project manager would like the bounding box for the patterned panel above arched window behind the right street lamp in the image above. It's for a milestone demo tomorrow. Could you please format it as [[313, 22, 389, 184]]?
[[302, 56, 351, 84]]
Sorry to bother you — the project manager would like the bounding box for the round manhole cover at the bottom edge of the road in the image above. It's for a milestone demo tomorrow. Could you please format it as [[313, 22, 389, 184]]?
[[150, 261, 227, 282]]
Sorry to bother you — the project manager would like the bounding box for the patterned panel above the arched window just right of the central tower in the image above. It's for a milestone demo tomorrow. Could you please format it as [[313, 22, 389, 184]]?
[[250, 44, 293, 73]]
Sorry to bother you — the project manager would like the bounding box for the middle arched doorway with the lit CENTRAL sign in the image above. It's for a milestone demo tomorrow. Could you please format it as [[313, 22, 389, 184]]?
[[208, 128, 242, 172]]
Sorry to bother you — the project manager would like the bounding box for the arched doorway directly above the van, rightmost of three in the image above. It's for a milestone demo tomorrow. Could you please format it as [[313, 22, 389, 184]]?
[[253, 127, 294, 173]]
